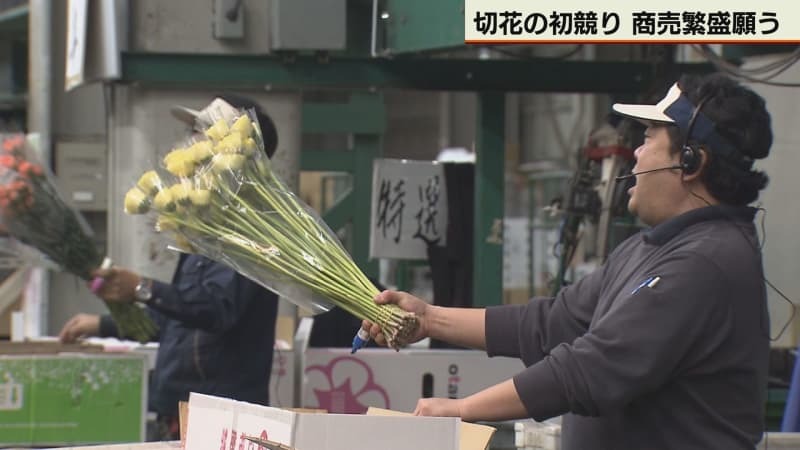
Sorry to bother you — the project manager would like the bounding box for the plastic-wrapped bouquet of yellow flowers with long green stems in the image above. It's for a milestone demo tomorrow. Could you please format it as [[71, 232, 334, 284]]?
[[125, 108, 418, 348]]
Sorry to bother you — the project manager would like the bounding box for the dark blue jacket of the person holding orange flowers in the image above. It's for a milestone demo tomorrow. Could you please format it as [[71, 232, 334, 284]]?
[[100, 254, 278, 417]]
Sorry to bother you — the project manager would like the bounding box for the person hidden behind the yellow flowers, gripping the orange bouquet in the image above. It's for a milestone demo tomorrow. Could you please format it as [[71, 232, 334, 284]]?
[[59, 95, 278, 440]]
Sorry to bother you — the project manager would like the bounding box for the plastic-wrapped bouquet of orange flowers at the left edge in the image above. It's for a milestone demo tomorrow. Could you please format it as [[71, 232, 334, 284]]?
[[0, 134, 157, 342]]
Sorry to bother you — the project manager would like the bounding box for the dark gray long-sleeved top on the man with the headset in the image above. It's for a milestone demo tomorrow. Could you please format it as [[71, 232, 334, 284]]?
[[486, 206, 769, 450]]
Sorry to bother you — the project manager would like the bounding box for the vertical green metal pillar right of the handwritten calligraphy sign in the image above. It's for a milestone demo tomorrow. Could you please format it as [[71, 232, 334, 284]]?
[[472, 92, 505, 306]]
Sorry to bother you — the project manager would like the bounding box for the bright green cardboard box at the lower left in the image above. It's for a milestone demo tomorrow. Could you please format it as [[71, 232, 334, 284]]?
[[0, 344, 147, 447]]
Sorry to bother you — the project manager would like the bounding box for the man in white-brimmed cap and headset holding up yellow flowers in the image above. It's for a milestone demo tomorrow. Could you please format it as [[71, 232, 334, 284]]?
[[364, 75, 772, 450]]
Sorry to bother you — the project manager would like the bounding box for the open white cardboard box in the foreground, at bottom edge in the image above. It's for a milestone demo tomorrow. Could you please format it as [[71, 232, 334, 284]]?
[[186, 393, 461, 450]]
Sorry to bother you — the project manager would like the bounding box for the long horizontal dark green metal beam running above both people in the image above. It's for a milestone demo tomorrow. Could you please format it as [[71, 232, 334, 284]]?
[[119, 52, 713, 93]]
